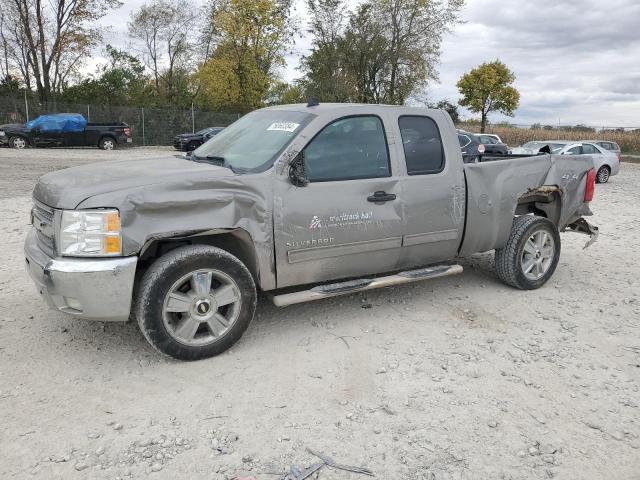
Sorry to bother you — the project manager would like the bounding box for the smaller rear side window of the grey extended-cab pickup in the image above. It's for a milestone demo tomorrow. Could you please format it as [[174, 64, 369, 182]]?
[[398, 115, 444, 175]]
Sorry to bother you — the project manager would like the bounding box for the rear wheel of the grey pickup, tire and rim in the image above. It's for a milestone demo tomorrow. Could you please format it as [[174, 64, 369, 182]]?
[[495, 215, 561, 290]]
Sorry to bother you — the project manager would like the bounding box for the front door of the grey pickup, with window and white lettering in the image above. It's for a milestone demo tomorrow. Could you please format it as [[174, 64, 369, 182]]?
[[274, 115, 402, 288]]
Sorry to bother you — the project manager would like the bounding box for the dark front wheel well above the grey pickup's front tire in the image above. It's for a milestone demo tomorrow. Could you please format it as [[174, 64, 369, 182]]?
[[138, 228, 260, 285]]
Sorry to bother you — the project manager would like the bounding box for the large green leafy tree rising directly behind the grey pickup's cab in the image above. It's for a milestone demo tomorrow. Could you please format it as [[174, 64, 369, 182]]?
[[301, 0, 463, 104]]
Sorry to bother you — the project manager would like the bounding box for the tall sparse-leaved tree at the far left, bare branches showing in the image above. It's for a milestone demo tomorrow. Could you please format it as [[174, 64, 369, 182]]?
[[2, 0, 121, 103]]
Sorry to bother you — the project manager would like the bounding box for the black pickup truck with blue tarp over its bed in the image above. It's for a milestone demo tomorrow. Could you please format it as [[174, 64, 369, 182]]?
[[0, 113, 132, 150]]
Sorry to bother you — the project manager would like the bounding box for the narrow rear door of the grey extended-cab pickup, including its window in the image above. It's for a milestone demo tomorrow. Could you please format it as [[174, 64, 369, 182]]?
[[395, 113, 466, 267]]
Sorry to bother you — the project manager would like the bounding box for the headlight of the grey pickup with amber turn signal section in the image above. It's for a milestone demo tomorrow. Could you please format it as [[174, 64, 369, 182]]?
[[58, 210, 122, 257]]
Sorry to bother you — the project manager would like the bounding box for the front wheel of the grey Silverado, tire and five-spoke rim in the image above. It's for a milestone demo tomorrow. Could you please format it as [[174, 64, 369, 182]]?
[[134, 245, 257, 360]]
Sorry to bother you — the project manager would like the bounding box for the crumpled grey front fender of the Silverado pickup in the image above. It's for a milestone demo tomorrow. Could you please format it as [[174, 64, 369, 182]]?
[[78, 174, 275, 289]]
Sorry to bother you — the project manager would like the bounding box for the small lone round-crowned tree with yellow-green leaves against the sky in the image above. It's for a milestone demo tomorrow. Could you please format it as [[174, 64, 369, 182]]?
[[457, 60, 520, 133]]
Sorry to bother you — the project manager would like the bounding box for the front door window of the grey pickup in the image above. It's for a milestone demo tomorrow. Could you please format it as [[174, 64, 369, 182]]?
[[304, 116, 391, 182]]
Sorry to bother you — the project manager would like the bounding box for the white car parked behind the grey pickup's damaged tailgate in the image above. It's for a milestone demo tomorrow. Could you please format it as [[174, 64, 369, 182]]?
[[511, 140, 620, 183]]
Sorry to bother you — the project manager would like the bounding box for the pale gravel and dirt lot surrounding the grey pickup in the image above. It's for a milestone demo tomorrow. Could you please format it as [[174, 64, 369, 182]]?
[[0, 149, 640, 480]]
